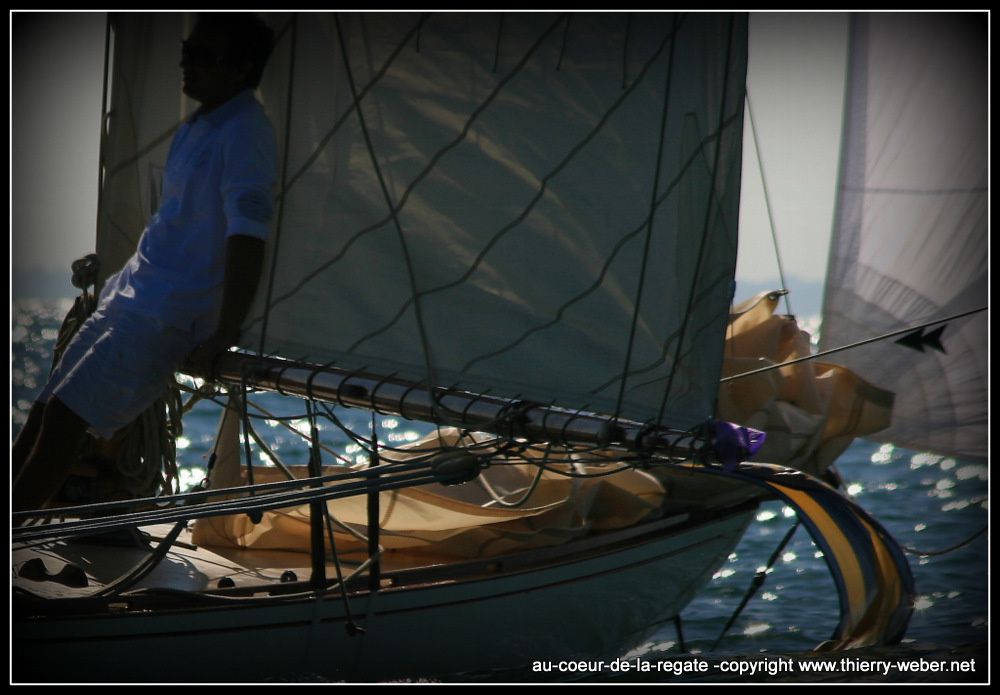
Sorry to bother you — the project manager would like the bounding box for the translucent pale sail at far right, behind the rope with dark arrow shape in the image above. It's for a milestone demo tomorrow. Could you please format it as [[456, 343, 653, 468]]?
[[820, 13, 988, 459]]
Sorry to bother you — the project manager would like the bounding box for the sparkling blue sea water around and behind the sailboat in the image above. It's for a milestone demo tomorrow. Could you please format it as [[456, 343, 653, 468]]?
[[11, 300, 989, 682]]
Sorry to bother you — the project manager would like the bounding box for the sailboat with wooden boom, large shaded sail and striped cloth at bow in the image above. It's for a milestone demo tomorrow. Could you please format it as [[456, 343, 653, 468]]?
[[12, 13, 985, 682]]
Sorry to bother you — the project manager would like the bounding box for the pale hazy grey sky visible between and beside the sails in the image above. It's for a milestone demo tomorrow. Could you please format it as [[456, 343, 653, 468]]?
[[10, 12, 846, 310]]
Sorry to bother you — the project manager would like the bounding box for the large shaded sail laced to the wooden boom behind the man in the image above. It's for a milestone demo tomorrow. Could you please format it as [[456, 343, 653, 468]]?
[[95, 13, 747, 428]]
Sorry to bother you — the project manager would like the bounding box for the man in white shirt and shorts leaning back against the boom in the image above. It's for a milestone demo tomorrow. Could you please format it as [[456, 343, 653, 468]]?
[[11, 13, 277, 511]]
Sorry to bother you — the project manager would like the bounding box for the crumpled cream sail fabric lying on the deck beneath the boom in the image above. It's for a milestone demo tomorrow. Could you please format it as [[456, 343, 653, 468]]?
[[193, 417, 664, 559]]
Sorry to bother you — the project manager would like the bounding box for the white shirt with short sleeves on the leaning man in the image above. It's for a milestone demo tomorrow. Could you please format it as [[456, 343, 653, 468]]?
[[101, 90, 277, 341]]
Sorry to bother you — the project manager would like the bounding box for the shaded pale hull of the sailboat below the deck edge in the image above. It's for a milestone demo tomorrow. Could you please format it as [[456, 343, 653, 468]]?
[[12, 509, 752, 682]]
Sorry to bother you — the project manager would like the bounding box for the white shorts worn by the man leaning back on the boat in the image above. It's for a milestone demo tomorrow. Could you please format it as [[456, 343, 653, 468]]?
[[36, 309, 196, 439]]
